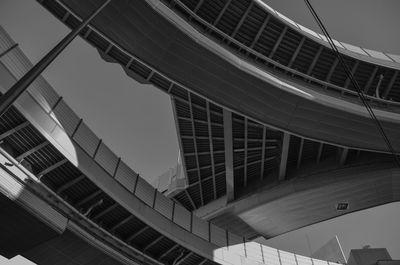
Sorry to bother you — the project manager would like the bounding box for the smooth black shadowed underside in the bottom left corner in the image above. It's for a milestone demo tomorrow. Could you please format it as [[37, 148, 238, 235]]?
[[0, 194, 125, 265]]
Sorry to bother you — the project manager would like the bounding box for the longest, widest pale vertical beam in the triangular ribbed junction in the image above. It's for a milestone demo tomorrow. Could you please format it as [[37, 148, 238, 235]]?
[[223, 109, 235, 202]]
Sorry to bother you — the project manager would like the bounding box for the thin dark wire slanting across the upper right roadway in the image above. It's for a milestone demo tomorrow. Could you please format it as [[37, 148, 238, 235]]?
[[304, 0, 400, 167]]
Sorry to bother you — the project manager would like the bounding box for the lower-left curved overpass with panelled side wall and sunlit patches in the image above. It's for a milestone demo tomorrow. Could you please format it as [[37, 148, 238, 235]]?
[[0, 24, 335, 265]]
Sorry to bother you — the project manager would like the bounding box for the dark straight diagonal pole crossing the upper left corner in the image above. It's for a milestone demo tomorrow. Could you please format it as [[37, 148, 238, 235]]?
[[0, 0, 111, 115]]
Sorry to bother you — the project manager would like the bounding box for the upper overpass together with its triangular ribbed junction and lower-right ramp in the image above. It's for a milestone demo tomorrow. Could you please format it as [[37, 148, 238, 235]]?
[[33, 0, 400, 238]]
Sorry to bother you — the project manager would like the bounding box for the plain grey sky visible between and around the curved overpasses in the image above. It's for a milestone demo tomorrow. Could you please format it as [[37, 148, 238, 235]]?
[[0, 0, 400, 265]]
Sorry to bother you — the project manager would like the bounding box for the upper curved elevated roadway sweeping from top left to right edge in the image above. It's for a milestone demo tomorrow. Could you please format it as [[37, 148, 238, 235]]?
[[40, 0, 400, 152]]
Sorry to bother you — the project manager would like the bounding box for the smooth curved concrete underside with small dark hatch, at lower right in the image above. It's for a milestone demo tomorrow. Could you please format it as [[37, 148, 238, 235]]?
[[209, 163, 400, 238]]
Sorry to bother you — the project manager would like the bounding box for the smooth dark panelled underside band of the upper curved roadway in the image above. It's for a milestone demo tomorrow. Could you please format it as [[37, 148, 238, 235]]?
[[55, 0, 400, 151]]
